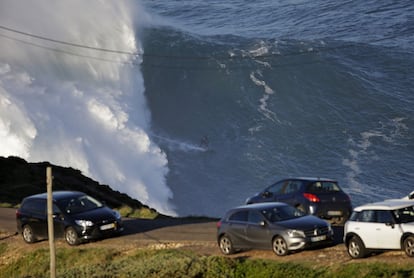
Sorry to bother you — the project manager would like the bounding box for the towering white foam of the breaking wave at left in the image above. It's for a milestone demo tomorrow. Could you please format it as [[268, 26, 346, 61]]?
[[0, 0, 175, 215]]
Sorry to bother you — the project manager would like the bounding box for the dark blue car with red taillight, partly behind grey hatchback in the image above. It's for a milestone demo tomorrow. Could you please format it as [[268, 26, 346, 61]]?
[[246, 178, 352, 224]]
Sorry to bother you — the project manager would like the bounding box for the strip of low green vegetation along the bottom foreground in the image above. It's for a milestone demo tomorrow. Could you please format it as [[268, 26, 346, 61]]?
[[0, 244, 414, 278]]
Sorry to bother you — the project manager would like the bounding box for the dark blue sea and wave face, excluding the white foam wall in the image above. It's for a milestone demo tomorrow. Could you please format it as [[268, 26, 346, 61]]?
[[138, 0, 414, 216]]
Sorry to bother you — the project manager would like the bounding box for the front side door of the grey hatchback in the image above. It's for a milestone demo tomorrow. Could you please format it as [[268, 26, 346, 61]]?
[[246, 210, 271, 249]]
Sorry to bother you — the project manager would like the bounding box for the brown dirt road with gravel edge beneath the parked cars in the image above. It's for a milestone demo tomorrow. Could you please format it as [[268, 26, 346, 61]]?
[[0, 208, 413, 267]]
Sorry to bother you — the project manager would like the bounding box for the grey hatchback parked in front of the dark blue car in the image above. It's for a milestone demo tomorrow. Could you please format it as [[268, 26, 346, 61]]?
[[217, 202, 333, 256]]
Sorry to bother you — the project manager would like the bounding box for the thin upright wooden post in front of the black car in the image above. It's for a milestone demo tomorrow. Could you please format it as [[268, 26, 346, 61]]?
[[46, 167, 56, 278]]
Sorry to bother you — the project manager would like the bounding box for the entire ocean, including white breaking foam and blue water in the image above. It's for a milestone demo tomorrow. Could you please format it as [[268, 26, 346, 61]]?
[[0, 0, 414, 216]]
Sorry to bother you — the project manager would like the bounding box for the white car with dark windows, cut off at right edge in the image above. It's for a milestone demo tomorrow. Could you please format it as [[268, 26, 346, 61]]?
[[344, 199, 414, 259]]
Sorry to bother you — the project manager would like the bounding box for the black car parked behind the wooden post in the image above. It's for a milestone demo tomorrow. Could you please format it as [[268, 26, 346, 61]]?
[[16, 191, 123, 245]]
